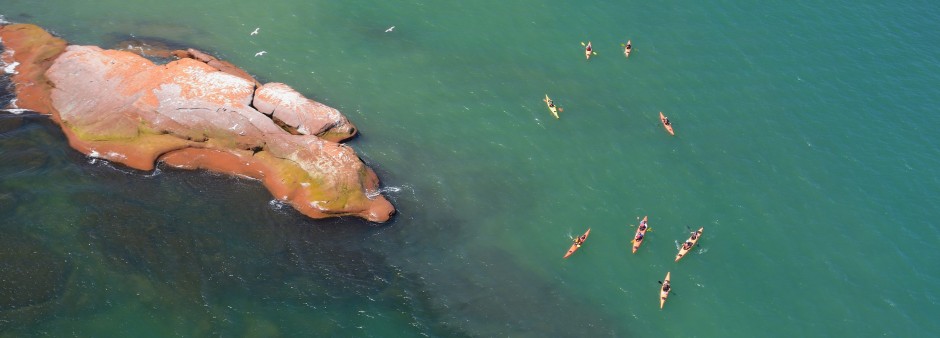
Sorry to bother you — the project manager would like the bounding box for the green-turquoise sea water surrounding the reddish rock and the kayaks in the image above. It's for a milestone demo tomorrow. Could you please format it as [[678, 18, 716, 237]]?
[[0, 0, 940, 337]]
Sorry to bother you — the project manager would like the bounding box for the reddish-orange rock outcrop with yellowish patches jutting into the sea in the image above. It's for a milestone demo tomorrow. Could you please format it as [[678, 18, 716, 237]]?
[[0, 24, 394, 222]]
